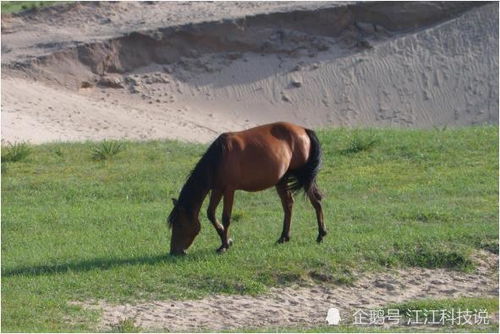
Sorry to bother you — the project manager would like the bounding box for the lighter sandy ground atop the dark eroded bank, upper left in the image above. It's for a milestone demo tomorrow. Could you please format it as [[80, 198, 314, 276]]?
[[2, 1, 349, 63]]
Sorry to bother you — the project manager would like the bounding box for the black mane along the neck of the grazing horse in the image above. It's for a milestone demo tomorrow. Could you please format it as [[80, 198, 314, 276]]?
[[168, 134, 225, 227]]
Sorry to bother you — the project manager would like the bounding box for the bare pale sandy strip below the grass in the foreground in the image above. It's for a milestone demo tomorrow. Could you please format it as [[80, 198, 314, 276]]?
[[72, 252, 498, 332]]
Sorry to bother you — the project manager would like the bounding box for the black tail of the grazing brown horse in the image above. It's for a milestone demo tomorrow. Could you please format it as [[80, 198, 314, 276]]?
[[285, 129, 322, 199]]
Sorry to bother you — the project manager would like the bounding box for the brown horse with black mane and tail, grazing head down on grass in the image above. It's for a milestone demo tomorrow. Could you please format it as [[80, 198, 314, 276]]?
[[168, 122, 326, 254]]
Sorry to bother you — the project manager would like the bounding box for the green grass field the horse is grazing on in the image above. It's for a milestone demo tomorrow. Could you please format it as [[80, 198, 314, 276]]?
[[2, 127, 498, 332]]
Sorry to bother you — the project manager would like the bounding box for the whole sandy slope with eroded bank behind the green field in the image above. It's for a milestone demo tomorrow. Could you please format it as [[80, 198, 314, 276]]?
[[1, 2, 498, 143]]
